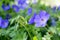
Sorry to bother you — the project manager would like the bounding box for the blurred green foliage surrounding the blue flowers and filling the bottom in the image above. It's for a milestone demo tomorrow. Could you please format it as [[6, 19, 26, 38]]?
[[0, 0, 60, 40]]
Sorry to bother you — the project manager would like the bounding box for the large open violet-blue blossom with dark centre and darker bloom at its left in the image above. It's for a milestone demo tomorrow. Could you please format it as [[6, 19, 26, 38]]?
[[29, 11, 50, 27]]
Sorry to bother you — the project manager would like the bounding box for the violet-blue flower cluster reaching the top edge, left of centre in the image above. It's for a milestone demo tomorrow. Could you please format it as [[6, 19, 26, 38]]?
[[12, 0, 28, 12]]
